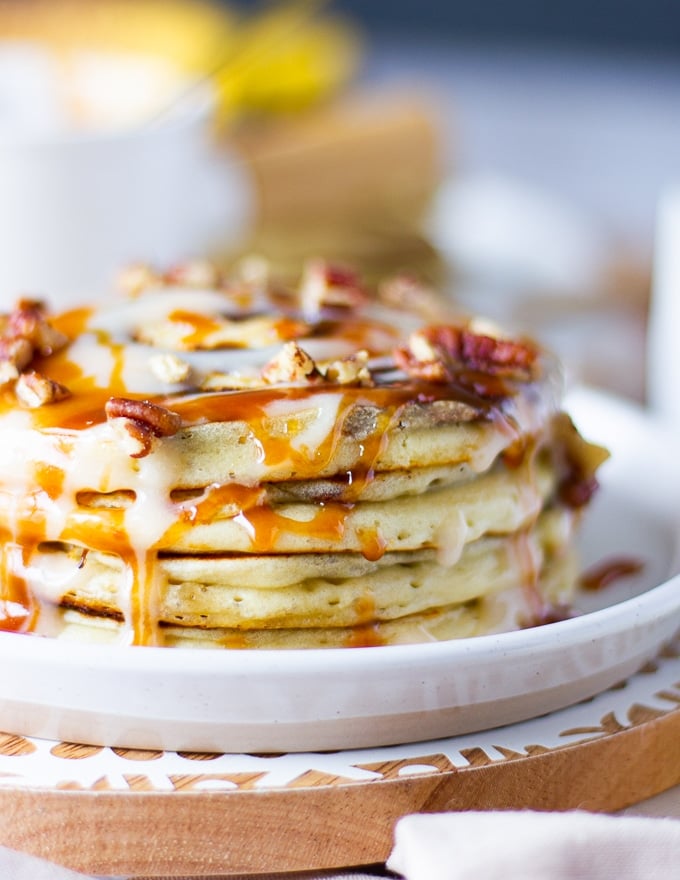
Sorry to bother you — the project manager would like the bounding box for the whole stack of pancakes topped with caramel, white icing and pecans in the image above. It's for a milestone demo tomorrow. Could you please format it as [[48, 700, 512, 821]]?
[[0, 261, 606, 648]]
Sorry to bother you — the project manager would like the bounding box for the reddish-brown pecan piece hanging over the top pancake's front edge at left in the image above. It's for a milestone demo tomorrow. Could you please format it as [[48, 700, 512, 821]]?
[[104, 397, 182, 458]]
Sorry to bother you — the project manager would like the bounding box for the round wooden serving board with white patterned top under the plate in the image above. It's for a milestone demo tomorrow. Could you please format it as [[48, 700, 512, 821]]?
[[0, 644, 680, 877]]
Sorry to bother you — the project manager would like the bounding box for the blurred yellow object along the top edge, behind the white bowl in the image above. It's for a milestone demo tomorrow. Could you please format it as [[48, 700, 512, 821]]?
[[0, 0, 360, 118]]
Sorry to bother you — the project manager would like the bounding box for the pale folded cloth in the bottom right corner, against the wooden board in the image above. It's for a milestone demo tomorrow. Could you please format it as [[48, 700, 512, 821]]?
[[387, 811, 680, 880]]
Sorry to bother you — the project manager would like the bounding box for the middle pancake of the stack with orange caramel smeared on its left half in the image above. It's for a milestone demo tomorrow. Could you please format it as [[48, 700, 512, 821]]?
[[27, 450, 555, 556]]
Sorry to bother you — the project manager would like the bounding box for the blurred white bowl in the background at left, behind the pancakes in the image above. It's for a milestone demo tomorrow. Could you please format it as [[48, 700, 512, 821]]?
[[0, 52, 250, 309]]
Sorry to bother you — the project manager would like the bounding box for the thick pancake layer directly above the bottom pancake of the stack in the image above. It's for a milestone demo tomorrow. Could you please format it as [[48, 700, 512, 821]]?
[[31, 511, 571, 630]]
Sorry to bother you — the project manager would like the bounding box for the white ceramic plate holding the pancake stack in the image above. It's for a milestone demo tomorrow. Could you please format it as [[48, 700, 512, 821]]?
[[0, 391, 680, 752]]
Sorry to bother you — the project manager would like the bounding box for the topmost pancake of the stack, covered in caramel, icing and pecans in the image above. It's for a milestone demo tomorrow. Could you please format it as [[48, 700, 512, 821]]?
[[0, 268, 560, 493]]
